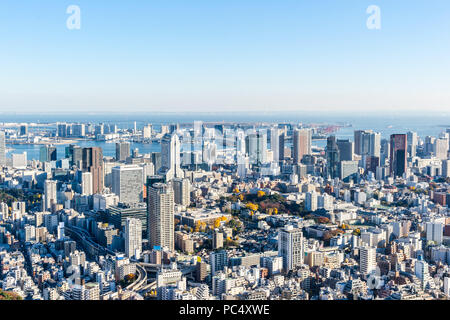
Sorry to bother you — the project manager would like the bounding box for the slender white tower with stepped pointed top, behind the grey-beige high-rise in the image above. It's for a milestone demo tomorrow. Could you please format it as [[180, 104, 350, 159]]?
[[159, 133, 184, 181]]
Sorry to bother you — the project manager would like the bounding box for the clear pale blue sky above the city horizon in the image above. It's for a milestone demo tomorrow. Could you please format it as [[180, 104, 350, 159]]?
[[0, 0, 450, 112]]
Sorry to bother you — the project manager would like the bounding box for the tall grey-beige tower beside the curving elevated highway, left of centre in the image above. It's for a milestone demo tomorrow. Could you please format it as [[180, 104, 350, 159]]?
[[147, 183, 174, 251]]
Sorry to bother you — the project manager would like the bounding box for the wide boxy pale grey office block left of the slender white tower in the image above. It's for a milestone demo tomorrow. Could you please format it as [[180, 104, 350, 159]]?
[[112, 165, 144, 204]]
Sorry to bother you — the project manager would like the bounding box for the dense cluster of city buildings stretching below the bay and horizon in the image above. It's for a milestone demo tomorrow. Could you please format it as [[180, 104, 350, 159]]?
[[0, 121, 450, 300]]
